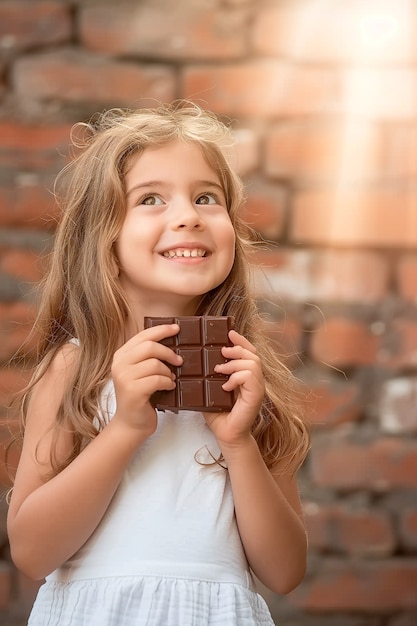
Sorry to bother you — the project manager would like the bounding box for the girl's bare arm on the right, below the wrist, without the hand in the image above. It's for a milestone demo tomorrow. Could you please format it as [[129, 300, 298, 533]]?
[[222, 436, 307, 593]]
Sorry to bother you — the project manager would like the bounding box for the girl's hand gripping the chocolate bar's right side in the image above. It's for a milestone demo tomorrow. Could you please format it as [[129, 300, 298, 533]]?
[[204, 330, 265, 448]]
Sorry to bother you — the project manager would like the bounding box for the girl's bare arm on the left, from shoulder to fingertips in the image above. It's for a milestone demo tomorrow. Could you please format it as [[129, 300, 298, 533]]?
[[8, 326, 178, 579]]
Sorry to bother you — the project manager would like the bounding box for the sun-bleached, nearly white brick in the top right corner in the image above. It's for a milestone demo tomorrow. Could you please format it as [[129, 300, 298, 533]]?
[[253, 0, 417, 63]]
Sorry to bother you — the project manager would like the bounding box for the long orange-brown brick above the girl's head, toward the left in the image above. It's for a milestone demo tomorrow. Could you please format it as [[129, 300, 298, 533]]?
[[14, 49, 175, 107]]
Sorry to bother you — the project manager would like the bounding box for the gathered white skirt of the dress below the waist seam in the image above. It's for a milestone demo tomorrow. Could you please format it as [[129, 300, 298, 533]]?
[[28, 576, 274, 626]]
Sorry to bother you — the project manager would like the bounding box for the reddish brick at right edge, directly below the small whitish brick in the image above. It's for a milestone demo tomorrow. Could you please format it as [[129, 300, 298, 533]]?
[[310, 435, 417, 491]]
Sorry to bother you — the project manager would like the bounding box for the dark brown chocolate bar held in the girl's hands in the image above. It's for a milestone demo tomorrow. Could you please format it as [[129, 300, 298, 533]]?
[[144, 316, 235, 412]]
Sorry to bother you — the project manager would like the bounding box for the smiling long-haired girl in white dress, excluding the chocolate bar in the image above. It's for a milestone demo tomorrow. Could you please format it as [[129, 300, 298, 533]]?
[[8, 103, 308, 626]]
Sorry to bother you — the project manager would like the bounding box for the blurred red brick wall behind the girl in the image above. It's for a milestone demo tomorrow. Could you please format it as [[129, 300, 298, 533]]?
[[0, 0, 417, 626]]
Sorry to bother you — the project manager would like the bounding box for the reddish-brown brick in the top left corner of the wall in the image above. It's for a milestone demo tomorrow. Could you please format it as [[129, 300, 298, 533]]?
[[0, 0, 72, 49]]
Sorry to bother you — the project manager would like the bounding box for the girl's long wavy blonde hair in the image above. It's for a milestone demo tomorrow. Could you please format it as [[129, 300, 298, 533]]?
[[16, 102, 309, 473]]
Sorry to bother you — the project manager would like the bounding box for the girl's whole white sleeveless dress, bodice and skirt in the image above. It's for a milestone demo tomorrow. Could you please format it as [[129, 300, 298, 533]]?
[[28, 383, 274, 626]]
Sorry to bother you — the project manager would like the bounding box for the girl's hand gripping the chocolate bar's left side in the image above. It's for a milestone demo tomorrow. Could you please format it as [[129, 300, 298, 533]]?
[[111, 324, 182, 436]]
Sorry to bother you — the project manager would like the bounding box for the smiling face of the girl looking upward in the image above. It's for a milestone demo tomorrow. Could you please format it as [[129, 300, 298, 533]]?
[[116, 141, 235, 323]]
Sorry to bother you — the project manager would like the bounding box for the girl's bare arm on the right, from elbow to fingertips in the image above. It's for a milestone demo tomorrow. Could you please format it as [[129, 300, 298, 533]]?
[[206, 331, 307, 593]]
